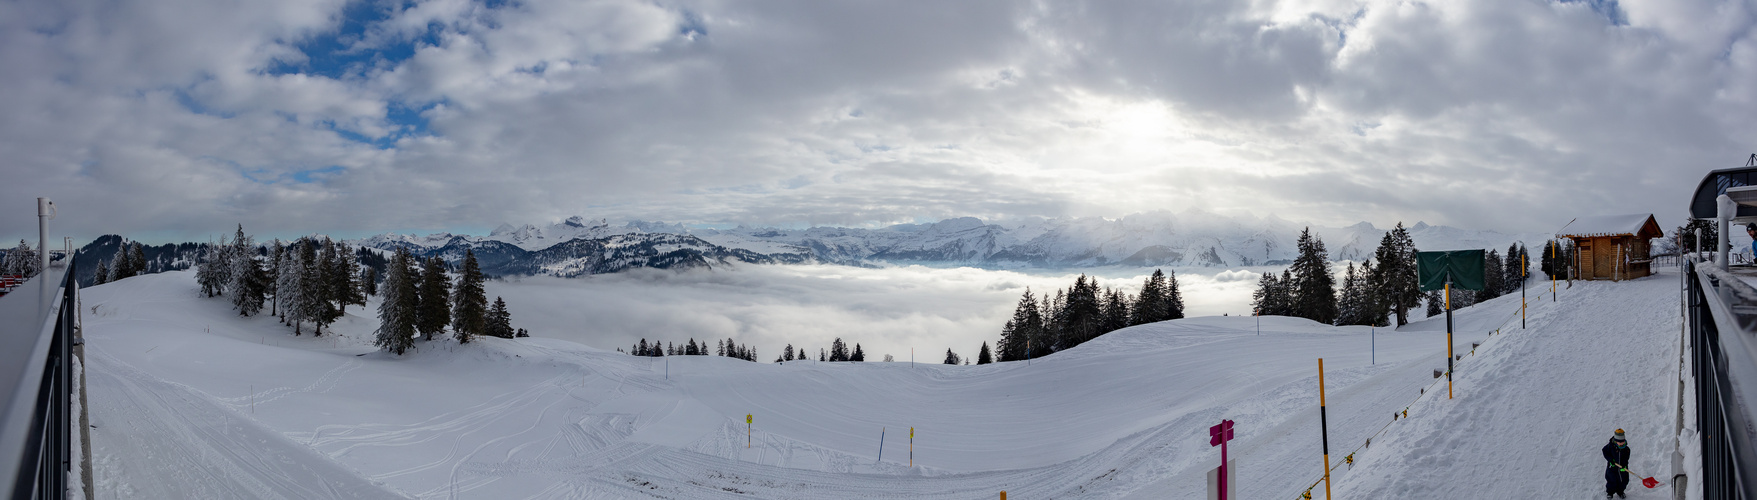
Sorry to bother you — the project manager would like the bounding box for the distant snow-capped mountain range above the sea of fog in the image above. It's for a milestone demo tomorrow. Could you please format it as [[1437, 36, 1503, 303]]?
[[355, 211, 1548, 277]]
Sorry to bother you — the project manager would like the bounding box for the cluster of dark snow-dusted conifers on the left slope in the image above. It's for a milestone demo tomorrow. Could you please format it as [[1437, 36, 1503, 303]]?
[[194, 225, 529, 356]]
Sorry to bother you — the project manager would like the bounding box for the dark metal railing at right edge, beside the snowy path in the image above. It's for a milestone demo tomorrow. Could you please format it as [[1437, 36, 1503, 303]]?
[[1683, 258, 1757, 500]]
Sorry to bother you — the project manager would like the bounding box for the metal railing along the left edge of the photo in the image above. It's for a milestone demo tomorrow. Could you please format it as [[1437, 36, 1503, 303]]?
[[0, 263, 79, 500]]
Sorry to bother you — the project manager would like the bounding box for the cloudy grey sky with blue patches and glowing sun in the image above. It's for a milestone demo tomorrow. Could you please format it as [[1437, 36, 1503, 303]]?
[[0, 0, 1757, 240]]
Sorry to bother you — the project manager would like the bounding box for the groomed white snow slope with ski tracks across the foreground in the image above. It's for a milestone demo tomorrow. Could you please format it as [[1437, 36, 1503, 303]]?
[[83, 270, 1678, 498]]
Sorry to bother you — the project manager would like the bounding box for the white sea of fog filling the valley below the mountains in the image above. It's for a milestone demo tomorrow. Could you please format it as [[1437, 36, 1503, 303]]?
[[487, 265, 1281, 363]]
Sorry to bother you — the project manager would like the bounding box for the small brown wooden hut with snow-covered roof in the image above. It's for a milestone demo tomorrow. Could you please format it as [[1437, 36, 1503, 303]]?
[[1557, 214, 1664, 281]]
